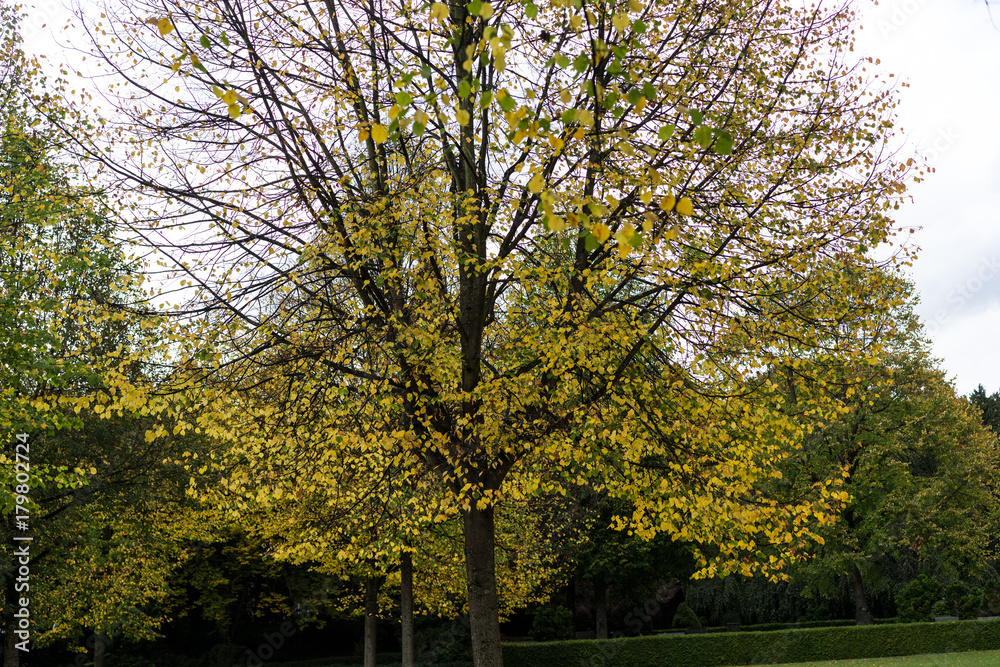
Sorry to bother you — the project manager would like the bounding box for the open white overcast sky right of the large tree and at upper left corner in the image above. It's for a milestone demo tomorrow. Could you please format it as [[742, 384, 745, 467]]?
[[13, 0, 1000, 394]]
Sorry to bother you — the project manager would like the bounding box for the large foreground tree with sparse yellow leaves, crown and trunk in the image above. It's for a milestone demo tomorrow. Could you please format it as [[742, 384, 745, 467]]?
[[68, 0, 910, 667]]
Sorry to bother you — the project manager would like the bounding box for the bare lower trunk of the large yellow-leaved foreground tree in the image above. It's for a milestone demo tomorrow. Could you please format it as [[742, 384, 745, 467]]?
[[462, 506, 503, 667]]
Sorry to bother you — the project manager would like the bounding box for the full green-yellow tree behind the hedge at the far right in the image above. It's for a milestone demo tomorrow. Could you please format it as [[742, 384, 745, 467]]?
[[764, 274, 1000, 625]]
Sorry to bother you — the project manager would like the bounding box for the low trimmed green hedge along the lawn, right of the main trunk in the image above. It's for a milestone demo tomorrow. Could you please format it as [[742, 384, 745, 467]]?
[[503, 620, 1000, 667]]
